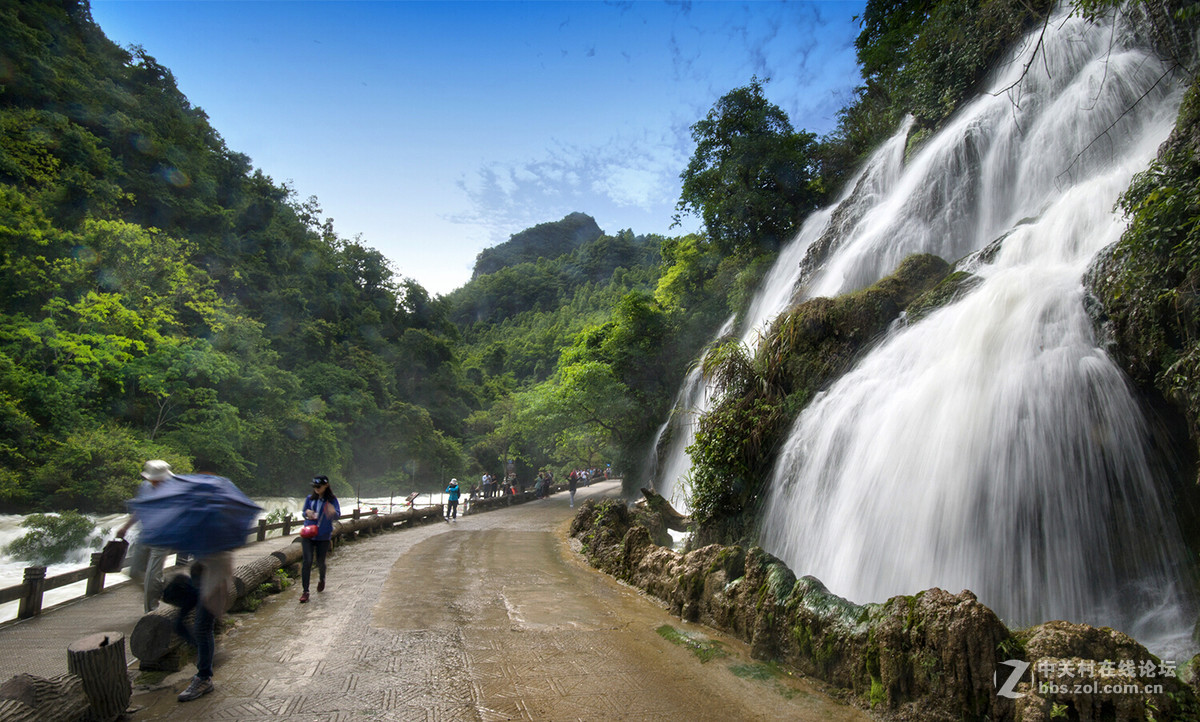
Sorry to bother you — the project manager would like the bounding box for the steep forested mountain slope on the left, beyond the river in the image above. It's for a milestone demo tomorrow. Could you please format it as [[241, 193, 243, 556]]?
[[0, 0, 479, 509]]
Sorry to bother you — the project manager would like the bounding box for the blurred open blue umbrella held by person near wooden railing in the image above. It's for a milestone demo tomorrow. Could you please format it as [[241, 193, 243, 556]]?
[[128, 474, 263, 556]]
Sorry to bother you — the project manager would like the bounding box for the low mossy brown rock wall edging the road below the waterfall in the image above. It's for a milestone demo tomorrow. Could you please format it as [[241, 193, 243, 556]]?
[[571, 500, 1200, 722]]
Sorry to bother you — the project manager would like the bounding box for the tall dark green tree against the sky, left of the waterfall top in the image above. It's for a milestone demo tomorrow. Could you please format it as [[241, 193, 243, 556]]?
[[676, 78, 824, 255]]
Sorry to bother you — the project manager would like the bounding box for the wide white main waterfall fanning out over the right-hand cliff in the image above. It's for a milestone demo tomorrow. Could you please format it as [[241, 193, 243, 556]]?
[[761, 8, 1194, 655]]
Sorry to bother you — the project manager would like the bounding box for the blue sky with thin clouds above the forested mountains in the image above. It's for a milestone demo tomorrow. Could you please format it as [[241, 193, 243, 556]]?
[[91, 0, 864, 294]]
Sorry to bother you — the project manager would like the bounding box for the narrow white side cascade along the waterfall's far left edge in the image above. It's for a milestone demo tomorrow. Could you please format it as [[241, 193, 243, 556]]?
[[648, 119, 912, 511]]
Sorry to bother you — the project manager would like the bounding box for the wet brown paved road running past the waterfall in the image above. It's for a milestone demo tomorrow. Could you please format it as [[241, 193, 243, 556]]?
[[133, 482, 866, 722]]
